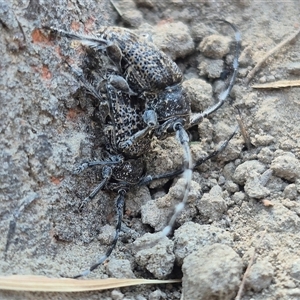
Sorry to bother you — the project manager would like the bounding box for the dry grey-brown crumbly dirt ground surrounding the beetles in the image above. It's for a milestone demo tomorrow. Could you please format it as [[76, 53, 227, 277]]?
[[0, 0, 300, 300]]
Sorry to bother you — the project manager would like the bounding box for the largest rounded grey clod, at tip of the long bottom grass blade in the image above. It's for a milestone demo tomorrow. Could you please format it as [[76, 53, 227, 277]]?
[[182, 244, 243, 300]]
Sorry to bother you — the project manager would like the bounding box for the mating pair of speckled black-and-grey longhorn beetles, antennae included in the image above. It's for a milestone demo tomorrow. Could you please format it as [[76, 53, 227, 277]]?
[[46, 21, 244, 278]]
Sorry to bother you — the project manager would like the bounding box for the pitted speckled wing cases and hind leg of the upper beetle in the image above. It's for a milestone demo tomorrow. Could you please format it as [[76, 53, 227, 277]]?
[[44, 26, 182, 94]]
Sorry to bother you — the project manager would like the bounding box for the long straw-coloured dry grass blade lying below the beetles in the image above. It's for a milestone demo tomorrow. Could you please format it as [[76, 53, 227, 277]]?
[[0, 275, 181, 292]]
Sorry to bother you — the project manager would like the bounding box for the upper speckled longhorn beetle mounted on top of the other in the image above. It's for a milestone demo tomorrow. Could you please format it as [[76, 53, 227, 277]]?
[[45, 20, 241, 169]]
